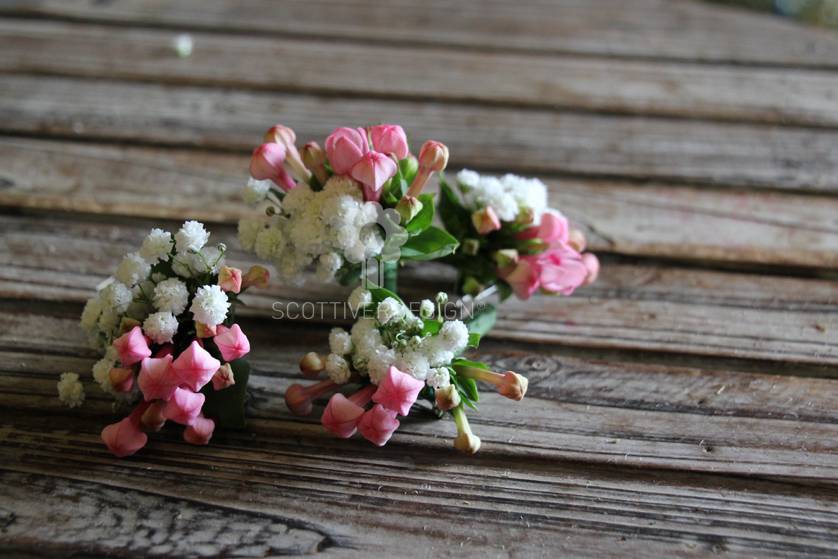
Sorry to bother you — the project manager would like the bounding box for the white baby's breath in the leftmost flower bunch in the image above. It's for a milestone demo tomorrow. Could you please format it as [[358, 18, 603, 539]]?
[[81, 221, 230, 354]]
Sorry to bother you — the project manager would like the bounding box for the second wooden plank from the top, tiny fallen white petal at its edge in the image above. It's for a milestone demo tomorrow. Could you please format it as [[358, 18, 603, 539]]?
[[0, 20, 838, 127]]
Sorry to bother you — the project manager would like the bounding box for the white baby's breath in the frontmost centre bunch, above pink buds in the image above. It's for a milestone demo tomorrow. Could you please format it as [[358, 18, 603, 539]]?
[[326, 287, 468, 388]]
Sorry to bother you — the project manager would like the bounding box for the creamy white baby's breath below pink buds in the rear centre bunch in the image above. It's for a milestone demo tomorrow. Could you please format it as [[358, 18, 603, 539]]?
[[239, 176, 384, 282]]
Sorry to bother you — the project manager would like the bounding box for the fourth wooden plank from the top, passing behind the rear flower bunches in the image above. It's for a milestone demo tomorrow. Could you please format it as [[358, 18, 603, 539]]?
[[0, 137, 838, 268]]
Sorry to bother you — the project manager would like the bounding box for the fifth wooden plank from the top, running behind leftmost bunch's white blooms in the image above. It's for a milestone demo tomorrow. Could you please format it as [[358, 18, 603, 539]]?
[[0, 215, 838, 366]]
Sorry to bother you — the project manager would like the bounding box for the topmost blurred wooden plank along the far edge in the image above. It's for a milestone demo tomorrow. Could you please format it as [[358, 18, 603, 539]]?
[[0, 0, 838, 68]]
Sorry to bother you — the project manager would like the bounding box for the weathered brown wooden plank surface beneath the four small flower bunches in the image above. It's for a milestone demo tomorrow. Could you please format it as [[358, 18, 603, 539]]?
[[0, 0, 838, 557]]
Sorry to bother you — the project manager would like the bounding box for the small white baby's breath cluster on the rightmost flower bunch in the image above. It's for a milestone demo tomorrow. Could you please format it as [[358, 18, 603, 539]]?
[[457, 169, 548, 225]]
